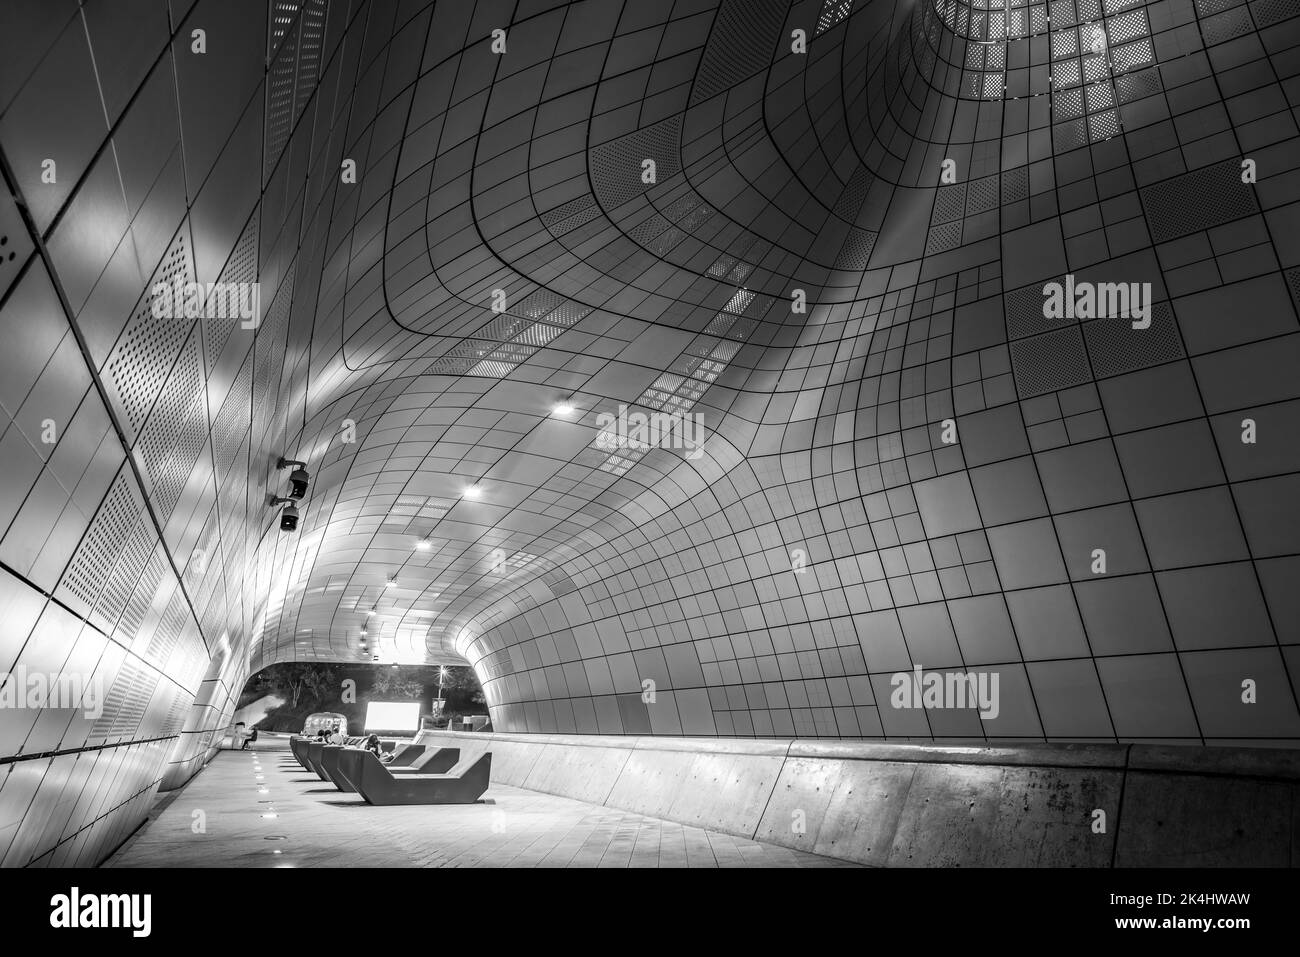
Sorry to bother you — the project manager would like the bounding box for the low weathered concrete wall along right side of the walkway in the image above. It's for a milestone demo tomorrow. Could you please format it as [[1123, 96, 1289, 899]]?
[[423, 732, 1300, 867]]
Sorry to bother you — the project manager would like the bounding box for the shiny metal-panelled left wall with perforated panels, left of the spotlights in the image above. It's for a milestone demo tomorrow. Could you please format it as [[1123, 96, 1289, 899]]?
[[0, 0, 324, 866]]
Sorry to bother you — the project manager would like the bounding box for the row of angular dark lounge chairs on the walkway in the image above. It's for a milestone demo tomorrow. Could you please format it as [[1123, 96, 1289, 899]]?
[[289, 737, 491, 805]]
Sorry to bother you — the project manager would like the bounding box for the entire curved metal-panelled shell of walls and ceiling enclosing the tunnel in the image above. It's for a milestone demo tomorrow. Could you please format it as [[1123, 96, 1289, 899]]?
[[0, 0, 1300, 865]]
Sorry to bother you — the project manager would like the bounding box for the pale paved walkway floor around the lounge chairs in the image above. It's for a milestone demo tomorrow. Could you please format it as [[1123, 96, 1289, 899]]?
[[104, 740, 855, 867]]
